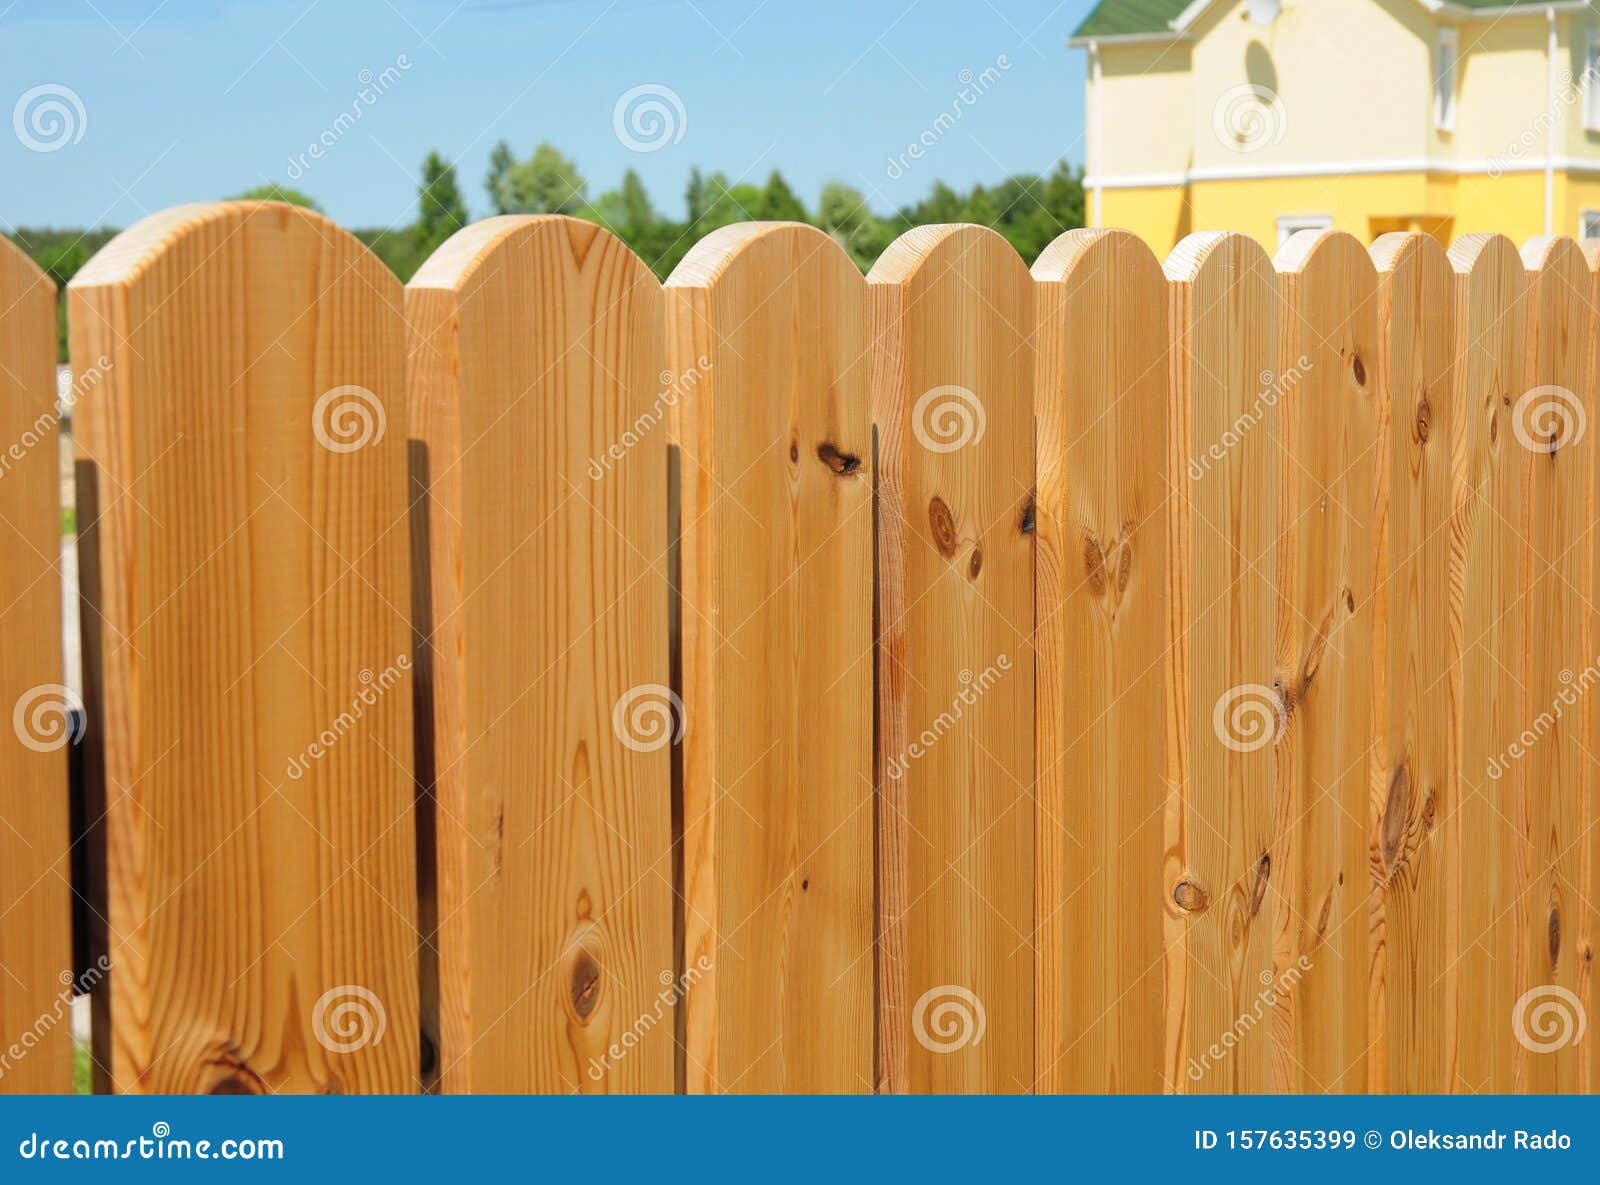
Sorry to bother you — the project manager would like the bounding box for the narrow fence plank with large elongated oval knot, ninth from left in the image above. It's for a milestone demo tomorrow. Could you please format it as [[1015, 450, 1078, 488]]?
[[1366, 233, 1467, 1094]]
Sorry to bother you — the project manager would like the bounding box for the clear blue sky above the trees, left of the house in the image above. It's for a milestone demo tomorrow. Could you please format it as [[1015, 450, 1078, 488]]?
[[0, 0, 1091, 229]]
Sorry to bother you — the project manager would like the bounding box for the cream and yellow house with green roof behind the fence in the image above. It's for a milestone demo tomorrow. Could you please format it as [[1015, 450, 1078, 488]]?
[[1069, 0, 1600, 253]]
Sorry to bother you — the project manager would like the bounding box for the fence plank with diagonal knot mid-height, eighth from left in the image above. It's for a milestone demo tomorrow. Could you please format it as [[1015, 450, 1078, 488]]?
[[1269, 232, 1382, 1094]]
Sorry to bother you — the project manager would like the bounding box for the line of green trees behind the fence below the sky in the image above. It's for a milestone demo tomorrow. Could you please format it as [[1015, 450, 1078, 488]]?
[[10, 141, 1085, 360]]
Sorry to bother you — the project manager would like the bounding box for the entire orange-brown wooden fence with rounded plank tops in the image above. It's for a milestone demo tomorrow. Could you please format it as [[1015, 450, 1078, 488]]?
[[0, 203, 1600, 1092]]
